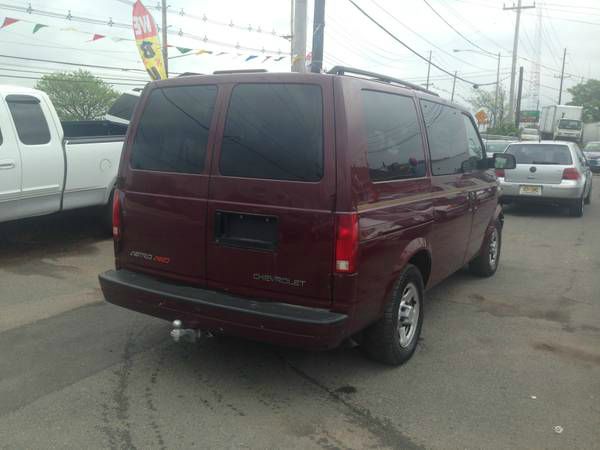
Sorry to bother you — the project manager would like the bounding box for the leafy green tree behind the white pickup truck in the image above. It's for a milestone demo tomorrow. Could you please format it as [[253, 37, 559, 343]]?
[[35, 69, 119, 120]]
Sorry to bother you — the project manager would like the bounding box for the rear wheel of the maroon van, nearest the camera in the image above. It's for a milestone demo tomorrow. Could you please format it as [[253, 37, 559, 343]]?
[[363, 264, 424, 366]]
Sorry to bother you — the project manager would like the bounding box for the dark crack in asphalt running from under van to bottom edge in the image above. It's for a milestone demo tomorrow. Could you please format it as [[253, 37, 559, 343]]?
[[277, 354, 424, 450]]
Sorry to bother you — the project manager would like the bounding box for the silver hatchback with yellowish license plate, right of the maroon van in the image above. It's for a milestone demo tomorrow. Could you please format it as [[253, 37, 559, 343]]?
[[497, 141, 592, 217]]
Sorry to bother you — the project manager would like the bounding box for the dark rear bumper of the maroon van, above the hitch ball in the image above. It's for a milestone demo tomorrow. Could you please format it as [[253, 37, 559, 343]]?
[[99, 270, 348, 349]]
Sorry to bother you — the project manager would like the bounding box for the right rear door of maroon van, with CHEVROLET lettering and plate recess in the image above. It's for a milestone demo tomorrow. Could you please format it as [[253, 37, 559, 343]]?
[[206, 79, 335, 306]]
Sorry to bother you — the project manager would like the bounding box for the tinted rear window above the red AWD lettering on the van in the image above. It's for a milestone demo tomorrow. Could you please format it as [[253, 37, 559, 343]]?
[[131, 86, 217, 173]]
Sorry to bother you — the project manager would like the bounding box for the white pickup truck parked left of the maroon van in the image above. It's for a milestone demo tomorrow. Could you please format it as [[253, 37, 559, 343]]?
[[0, 85, 127, 229]]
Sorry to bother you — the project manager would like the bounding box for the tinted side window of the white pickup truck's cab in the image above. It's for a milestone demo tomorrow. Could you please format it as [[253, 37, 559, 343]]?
[[6, 95, 50, 145]]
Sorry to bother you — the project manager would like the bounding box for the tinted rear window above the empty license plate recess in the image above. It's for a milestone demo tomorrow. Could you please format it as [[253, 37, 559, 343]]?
[[219, 84, 323, 181]]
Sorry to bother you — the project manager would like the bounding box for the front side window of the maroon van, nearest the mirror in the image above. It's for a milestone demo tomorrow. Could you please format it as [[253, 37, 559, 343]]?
[[421, 100, 469, 175]]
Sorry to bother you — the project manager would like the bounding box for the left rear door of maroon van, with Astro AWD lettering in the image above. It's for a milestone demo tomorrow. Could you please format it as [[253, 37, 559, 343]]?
[[117, 80, 218, 285]]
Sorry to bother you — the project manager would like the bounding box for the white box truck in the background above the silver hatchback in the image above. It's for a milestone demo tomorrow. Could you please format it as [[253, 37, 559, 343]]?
[[540, 105, 583, 142]]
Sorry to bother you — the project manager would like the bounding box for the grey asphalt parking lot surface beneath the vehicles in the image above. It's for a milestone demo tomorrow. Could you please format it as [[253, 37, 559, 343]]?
[[0, 187, 600, 449]]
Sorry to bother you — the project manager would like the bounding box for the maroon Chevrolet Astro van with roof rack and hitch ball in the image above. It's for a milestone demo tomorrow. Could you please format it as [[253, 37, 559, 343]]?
[[100, 67, 514, 364]]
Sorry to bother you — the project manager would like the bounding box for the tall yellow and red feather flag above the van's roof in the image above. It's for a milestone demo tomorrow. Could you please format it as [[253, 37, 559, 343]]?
[[133, 0, 167, 80]]
